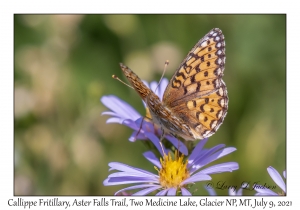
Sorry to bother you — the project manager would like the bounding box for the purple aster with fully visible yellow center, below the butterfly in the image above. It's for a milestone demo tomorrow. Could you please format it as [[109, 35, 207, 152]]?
[[103, 139, 239, 196]]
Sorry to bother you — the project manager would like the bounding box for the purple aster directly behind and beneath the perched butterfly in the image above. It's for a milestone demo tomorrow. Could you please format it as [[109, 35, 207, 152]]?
[[101, 78, 188, 155]]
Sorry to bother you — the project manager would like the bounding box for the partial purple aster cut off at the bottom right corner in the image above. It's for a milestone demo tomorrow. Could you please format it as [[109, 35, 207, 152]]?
[[253, 166, 286, 195]]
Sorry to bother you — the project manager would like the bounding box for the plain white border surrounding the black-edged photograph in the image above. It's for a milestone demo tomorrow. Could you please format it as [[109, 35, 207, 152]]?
[[0, 0, 300, 209]]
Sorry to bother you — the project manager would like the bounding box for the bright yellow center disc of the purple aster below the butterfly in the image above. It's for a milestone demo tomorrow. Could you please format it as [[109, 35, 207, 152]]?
[[156, 150, 190, 188]]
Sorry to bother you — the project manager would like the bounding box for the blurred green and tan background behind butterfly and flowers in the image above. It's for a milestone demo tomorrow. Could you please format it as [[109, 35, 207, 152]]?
[[14, 15, 286, 195]]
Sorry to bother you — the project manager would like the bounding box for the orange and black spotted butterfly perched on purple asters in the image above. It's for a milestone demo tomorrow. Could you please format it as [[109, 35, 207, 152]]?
[[120, 28, 228, 140]]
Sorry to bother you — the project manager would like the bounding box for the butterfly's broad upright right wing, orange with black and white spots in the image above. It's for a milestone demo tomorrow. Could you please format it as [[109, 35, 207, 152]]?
[[163, 29, 228, 138]]
